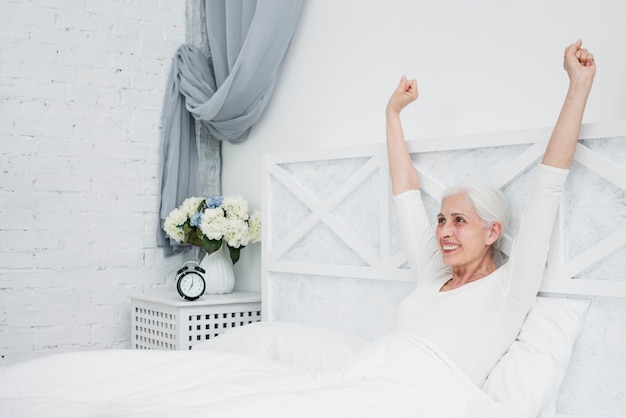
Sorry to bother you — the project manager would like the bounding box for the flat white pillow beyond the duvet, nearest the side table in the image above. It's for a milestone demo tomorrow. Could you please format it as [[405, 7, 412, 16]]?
[[193, 321, 369, 370]]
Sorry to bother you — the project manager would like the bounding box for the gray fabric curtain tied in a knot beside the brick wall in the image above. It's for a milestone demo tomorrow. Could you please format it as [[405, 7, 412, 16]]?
[[157, 0, 303, 255]]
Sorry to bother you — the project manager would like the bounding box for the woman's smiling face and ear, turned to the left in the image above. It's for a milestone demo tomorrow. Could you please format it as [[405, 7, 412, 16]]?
[[436, 193, 499, 268]]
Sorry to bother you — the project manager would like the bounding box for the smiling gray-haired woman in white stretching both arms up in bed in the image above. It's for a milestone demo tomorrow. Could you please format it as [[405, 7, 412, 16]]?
[[386, 40, 596, 387]]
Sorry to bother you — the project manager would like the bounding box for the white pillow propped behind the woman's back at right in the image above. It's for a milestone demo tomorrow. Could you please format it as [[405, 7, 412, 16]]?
[[483, 297, 589, 418]]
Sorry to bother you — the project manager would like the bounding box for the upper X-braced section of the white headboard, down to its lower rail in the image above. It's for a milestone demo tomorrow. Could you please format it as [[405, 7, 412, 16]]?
[[263, 121, 626, 316]]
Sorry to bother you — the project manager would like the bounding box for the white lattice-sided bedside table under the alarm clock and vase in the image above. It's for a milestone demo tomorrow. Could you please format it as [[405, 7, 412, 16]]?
[[131, 291, 261, 350]]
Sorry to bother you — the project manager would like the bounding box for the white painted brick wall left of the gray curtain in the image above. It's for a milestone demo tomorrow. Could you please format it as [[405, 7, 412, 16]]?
[[0, 0, 186, 364]]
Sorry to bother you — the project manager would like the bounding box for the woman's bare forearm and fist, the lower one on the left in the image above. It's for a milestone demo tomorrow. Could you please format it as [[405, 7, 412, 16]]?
[[385, 76, 419, 196]]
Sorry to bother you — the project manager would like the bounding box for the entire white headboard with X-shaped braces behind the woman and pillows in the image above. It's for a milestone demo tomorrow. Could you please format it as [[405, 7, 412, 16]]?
[[262, 121, 626, 416]]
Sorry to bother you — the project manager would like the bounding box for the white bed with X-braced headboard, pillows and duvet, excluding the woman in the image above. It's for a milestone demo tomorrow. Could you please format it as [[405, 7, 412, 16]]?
[[0, 121, 626, 418]]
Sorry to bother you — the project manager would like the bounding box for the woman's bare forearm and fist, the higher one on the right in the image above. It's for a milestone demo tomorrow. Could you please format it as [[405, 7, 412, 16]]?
[[542, 39, 596, 168]]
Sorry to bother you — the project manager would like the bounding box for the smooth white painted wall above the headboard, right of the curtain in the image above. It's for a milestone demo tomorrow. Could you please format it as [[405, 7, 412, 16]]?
[[222, 0, 626, 290]]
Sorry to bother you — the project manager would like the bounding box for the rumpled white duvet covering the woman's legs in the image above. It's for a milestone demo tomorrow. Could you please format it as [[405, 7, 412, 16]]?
[[0, 334, 521, 418]]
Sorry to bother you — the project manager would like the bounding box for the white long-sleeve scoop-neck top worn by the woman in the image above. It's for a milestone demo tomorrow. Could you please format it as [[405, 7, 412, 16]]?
[[394, 164, 569, 387]]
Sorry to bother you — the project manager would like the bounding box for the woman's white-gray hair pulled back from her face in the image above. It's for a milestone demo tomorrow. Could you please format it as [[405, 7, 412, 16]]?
[[442, 180, 511, 249]]
